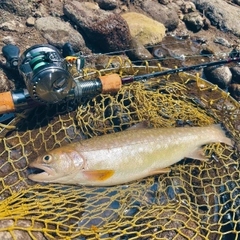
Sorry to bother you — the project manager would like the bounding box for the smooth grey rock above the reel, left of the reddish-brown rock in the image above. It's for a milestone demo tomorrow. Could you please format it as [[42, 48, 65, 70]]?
[[35, 17, 86, 51]]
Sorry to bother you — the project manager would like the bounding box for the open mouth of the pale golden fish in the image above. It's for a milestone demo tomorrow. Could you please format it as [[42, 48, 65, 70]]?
[[28, 163, 55, 182]]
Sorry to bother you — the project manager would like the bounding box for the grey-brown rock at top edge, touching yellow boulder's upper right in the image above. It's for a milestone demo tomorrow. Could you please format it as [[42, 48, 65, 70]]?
[[141, 0, 179, 31]]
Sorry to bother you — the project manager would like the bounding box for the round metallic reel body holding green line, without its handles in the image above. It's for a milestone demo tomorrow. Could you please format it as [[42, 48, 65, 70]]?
[[18, 44, 73, 103]]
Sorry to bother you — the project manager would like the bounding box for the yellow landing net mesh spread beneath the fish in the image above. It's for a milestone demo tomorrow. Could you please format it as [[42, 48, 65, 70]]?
[[0, 59, 240, 240]]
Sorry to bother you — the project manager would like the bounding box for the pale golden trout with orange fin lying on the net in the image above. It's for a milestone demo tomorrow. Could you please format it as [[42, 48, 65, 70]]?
[[28, 124, 233, 186]]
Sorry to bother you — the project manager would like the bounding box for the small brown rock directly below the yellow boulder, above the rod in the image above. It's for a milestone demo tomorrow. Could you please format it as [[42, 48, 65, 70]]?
[[127, 38, 153, 61]]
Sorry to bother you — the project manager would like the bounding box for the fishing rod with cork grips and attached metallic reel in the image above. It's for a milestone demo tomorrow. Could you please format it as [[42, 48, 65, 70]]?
[[0, 43, 240, 122]]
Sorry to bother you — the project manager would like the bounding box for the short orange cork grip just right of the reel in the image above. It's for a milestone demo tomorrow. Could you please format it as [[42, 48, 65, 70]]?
[[99, 73, 122, 93]]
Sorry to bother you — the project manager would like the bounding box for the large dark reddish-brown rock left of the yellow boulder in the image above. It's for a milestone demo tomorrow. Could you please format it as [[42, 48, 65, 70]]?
[[64, 1, 131, 52]]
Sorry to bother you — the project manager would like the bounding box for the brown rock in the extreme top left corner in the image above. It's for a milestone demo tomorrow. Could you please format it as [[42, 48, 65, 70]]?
[[0, 0, 31, 17]]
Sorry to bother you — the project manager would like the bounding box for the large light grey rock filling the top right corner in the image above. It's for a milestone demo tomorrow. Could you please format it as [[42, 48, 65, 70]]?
[[192, 0, 240, 37]]
